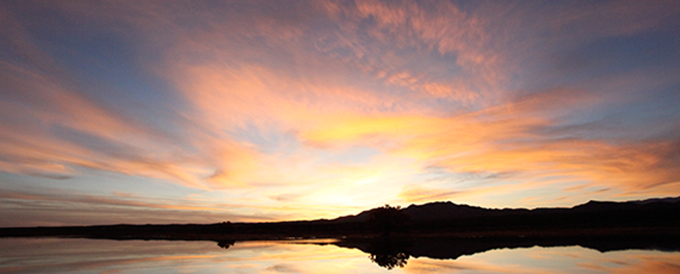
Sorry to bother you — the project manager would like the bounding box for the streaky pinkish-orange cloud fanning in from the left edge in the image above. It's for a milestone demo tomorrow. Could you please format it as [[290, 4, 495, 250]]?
[[0, 11, 268, 188]]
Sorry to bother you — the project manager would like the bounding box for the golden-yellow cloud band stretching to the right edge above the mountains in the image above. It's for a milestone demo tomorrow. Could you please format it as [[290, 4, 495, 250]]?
[[300, 90, 680, 201]]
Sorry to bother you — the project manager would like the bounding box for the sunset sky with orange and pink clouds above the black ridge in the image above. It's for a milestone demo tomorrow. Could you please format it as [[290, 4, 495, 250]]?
[[0, 0, 680, 227]]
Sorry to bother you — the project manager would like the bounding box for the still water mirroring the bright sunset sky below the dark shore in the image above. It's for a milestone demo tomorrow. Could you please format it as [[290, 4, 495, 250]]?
[[0, 238, 680, 274]]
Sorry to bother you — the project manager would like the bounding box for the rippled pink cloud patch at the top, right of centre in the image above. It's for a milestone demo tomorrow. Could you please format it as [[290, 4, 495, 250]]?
[[318, 1, 505, 108]]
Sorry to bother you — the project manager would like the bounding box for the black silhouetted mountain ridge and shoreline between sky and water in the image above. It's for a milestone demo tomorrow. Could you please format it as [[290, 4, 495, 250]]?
[[0, 197, 680, 241]]
